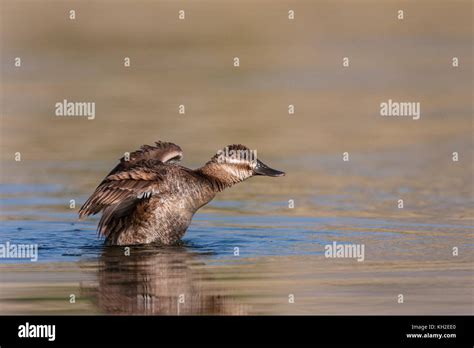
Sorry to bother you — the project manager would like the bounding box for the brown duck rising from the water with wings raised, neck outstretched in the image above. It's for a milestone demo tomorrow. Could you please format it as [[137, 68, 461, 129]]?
[[79, 141, 285, 246]]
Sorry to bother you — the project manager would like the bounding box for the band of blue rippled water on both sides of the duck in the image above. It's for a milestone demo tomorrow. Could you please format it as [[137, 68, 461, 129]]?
[[0, 209, 474, 263]]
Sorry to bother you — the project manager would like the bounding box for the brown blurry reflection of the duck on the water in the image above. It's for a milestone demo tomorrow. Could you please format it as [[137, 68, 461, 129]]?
[[85, 246, 245, 315]]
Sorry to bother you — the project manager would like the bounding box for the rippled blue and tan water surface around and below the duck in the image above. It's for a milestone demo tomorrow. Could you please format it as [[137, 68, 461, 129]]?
[[0, 156, 474, 315]]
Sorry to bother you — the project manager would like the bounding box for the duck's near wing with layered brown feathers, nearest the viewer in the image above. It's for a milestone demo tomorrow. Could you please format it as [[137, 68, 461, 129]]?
[[79, 160, 170, 236]]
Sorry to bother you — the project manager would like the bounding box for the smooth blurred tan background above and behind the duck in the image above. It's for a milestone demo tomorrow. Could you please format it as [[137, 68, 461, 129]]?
[[1, 0, 473, 220]]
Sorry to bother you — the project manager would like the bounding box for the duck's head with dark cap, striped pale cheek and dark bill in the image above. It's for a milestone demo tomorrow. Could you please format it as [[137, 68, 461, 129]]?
[[201, 144, 285, 186]]
